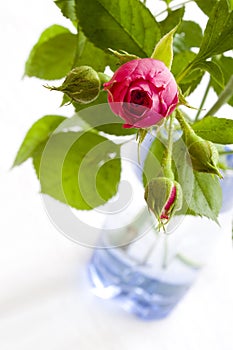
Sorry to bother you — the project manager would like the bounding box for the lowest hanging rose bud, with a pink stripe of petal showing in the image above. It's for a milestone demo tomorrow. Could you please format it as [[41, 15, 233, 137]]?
[[145, 177, 182, 222]]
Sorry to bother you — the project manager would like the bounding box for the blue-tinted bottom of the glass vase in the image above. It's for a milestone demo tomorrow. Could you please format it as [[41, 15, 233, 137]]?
[[88, 249, 190, 320]]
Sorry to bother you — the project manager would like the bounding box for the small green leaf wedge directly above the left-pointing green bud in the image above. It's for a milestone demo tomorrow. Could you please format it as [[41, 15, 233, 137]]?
[[74, 30, 117, 72]]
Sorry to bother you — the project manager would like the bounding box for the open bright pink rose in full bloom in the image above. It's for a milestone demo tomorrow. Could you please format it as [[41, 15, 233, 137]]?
[[104, 58, 178, 128]]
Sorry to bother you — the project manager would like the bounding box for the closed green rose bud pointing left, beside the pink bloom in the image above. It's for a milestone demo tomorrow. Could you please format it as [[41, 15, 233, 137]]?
[[46, 66, 101, 103]]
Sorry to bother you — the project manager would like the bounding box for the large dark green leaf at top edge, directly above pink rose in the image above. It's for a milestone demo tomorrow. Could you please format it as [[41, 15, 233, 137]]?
[[76, 0, 160, 57]]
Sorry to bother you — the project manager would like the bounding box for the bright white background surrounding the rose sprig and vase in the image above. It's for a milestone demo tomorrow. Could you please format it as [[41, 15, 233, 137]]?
[[0, 0, 233, 350]]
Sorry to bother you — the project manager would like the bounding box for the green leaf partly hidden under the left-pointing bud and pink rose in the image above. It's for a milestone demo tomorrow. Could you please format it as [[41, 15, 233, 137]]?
[[74, 95, 138, 136]]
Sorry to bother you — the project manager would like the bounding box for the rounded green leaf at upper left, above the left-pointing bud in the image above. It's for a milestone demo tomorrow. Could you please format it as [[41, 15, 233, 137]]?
[[25, 25, 76, 80]]
